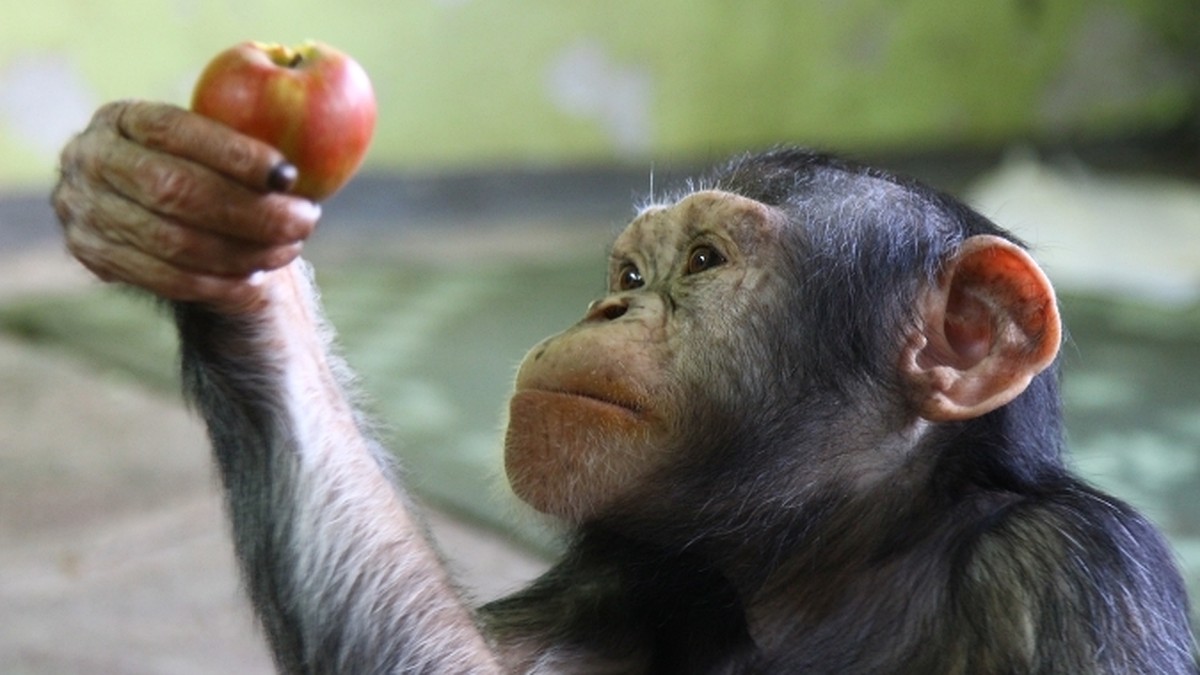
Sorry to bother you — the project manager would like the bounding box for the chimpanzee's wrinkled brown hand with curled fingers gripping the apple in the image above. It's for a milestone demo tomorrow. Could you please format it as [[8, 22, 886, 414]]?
[[53, 101, 320, 312]]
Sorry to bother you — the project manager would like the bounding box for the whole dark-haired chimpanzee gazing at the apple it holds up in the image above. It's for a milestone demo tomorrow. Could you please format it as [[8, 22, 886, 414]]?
[[54, 102, 1196, 675]]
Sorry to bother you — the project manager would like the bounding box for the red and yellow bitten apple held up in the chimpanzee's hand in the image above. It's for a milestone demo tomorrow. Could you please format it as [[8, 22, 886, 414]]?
[[192, 41, 376, 202]]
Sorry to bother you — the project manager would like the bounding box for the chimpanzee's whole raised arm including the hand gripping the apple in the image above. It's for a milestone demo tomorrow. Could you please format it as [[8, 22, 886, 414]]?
[[54, 103, 498, 673]]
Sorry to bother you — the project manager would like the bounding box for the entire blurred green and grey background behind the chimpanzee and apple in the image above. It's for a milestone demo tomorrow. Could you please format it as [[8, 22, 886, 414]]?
[[0, 0, 1200, 673]]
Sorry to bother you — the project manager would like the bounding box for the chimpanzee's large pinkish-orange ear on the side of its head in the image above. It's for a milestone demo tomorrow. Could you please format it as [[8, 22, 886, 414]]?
[[900, 235, 1062, 422]]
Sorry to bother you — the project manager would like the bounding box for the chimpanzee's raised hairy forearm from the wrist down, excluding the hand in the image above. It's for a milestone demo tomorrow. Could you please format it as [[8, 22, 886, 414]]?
[[175, 263, 498, 673]]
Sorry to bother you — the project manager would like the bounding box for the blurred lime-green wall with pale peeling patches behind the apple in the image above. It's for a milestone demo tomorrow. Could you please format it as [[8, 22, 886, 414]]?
[[0, 0, 1200, 189]]
